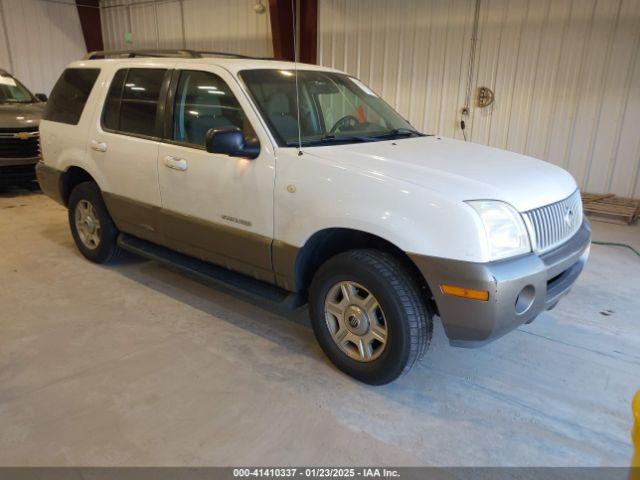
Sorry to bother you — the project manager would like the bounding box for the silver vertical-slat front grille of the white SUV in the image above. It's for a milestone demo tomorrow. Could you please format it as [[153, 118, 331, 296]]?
[[524, 190, 582, 253]]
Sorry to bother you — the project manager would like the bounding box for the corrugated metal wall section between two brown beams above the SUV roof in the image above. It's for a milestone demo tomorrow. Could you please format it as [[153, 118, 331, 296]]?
[[100, 0, 273, 56]]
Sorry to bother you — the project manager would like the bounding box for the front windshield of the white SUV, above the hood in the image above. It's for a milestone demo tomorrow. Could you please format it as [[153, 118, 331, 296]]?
[[240, 69, 422, 147]]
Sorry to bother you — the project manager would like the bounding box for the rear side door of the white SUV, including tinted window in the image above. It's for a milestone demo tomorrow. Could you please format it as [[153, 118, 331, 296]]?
[[88, 66, 171, 241]]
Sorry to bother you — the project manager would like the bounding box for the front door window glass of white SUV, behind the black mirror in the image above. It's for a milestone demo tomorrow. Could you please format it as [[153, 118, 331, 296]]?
[[173, 70, 255, 146]]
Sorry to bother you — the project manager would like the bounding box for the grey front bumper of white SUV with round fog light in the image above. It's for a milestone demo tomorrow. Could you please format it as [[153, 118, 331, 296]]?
[[411, 218, 591, 347]]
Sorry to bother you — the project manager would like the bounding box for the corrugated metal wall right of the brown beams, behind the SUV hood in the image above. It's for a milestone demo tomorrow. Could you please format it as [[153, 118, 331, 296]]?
[[318, 0, 640, 197]]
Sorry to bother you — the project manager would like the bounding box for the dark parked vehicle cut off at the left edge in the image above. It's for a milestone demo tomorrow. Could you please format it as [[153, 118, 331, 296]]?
[[0, 70, 47, 187]]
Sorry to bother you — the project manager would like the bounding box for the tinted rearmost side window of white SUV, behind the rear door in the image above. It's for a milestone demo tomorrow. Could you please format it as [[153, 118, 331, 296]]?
[[43, 68, 100, 125]]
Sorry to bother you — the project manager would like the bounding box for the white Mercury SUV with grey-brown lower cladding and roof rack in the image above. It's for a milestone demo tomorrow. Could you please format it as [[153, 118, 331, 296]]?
[[37, 51, 591, 384]]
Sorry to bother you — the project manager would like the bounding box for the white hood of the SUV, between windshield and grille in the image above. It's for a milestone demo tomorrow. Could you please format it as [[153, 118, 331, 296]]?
[[304, 136, 577, 212]]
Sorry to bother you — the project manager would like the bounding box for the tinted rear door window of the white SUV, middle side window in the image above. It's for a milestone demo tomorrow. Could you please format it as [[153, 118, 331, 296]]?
[[102, 68, 166, 137]]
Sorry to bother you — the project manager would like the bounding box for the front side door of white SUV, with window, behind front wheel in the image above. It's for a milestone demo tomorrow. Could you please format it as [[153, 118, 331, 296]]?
[[158, 64, 275, 281]]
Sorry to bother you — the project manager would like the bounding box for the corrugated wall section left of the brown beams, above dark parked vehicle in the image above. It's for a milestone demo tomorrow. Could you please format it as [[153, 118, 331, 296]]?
[[0, 0, 87, 94]]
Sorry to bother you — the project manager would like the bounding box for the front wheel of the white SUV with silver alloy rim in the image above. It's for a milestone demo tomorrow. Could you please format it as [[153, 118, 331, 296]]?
[[309, 250, 433, 385]]
